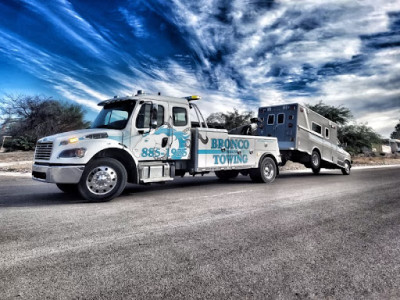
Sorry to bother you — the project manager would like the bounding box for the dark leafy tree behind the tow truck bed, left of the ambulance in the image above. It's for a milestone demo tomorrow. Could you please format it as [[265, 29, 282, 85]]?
[[206, 108, 253, 130]]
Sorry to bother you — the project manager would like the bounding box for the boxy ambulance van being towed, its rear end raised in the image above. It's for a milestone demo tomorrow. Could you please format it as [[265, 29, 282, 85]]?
[[257, 103, 351, 175]]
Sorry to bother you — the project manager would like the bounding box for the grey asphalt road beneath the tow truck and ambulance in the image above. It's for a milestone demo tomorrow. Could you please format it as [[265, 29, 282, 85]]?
[[0, 167, 400, 299]]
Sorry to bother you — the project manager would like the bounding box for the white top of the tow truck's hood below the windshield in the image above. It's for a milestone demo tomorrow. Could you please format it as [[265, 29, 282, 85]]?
[[38, 128, 122, 143]]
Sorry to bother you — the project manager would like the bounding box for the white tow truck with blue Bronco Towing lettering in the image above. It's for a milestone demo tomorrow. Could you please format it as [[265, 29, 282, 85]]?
[[32, 91, 281, 201]]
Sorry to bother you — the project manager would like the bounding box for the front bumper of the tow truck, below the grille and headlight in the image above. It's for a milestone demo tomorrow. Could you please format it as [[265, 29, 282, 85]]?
[[32, 164, 85, 183]]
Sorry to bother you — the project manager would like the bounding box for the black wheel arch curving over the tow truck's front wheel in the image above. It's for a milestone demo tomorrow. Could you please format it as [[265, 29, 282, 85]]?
[[91, 148, 139, 183]]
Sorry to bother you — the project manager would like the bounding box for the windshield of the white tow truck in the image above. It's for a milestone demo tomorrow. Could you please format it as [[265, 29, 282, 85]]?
[[91, 101, 136, 129]]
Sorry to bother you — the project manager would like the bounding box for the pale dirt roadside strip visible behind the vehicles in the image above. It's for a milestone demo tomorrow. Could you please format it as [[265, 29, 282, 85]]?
[[0, 151, 400, 173]]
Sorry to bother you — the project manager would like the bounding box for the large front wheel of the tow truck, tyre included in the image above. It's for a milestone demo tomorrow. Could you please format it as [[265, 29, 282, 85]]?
[[78, 158, 128, 202]]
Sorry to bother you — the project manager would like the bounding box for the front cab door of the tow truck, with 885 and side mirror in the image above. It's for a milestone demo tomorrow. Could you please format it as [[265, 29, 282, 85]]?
[[131, 102, 169, 160]]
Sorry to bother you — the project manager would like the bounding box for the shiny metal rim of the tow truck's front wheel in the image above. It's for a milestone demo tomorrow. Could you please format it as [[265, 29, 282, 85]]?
[[86, 166, 118, 195]]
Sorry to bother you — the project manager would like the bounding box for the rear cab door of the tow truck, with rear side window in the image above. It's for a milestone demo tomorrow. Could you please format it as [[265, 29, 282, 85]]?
[[165, 103, 191, 160]]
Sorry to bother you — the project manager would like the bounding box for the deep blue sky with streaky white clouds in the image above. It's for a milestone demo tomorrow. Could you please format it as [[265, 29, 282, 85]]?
[[0, 0, 400, 136]]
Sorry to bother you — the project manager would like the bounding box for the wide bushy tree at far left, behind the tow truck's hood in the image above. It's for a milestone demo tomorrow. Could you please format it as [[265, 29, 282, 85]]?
[[0, 95, 89, 150]]
